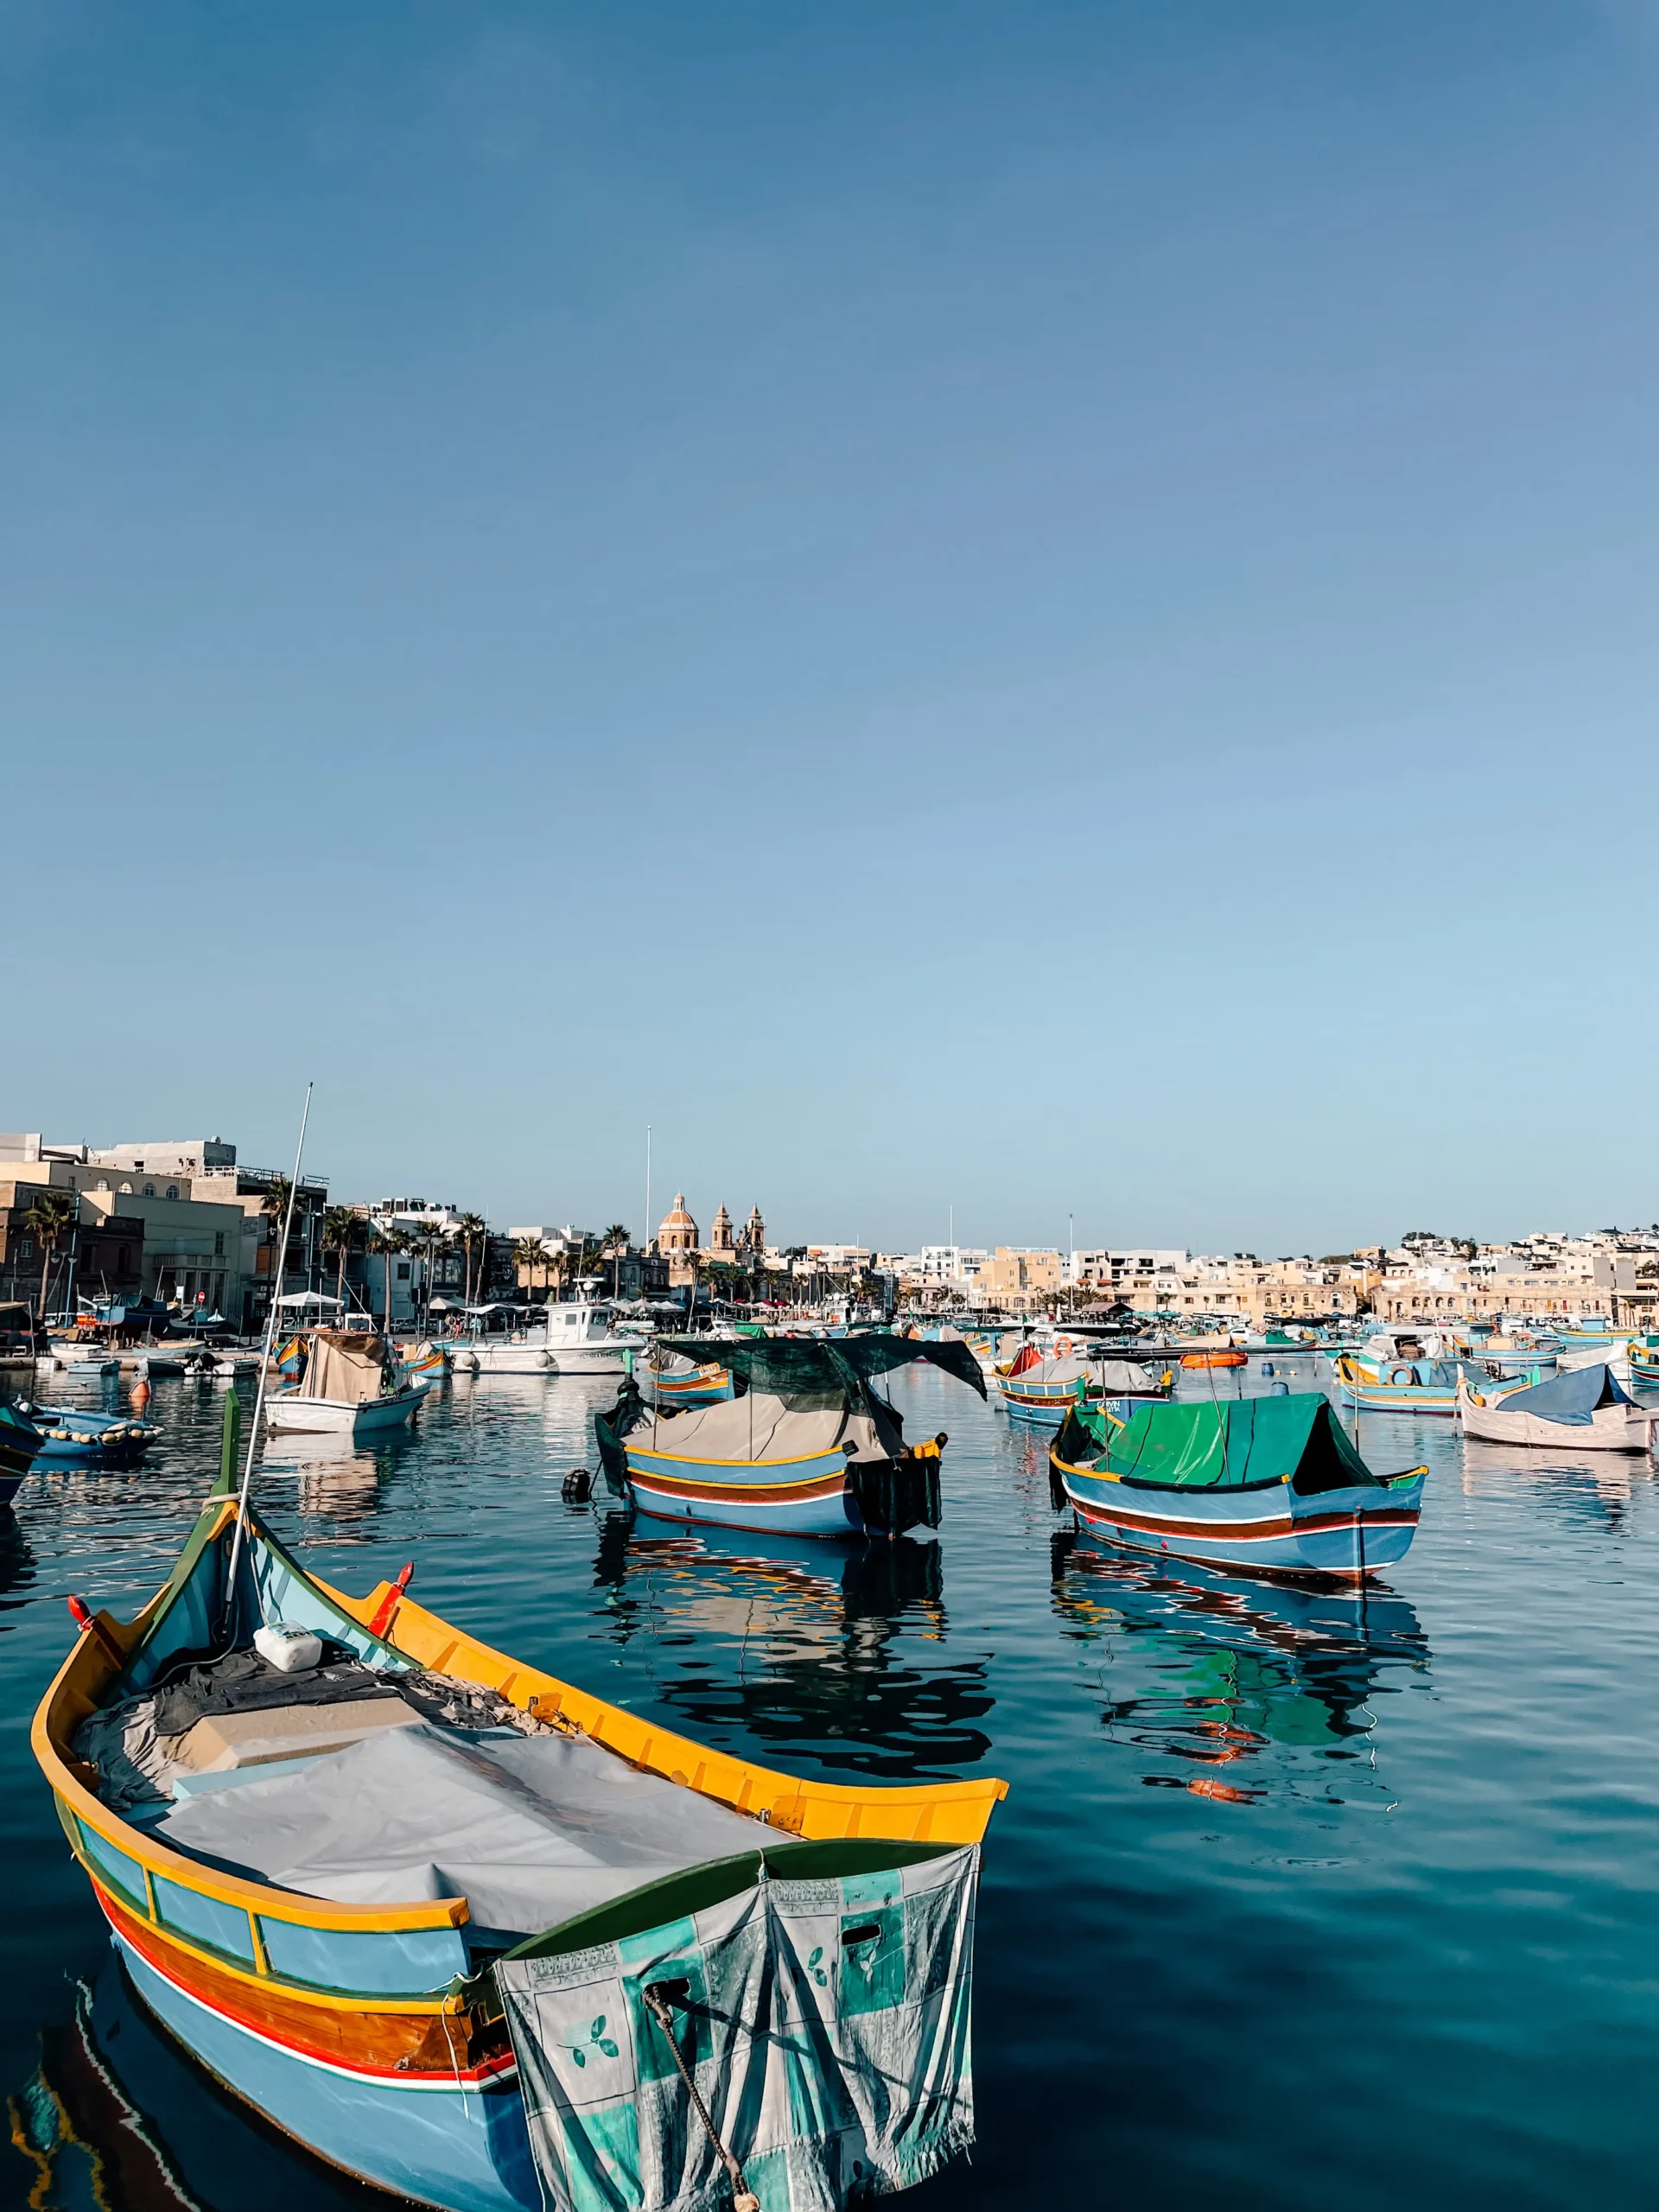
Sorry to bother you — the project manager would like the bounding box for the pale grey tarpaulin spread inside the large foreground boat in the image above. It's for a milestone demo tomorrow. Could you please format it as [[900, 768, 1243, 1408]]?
[[155, 1723, 777, 1936]]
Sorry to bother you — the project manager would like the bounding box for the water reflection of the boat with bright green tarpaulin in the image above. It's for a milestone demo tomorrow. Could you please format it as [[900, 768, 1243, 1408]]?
[[1053, 1531, 1429, 1802]]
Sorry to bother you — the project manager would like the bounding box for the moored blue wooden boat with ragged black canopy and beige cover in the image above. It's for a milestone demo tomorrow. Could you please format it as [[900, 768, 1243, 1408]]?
[[593, 1334, 984, 1537]]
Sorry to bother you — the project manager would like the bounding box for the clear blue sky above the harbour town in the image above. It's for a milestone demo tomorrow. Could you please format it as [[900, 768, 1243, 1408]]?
[[0, 0, 1659, 1252]]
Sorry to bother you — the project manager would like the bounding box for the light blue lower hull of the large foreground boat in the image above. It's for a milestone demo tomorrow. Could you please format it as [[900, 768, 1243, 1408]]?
[[115, 1936, 542, 2212]]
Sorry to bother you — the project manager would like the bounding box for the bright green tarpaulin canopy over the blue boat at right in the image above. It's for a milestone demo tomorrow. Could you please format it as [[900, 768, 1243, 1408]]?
[[1055, 1391, 1376, 1491]]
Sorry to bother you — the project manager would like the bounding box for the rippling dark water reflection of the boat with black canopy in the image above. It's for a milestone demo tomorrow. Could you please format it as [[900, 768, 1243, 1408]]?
[[595, 1513, 993, 1781]]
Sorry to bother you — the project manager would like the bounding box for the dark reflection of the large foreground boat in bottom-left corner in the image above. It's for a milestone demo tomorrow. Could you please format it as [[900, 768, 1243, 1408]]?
[[7, 1951, 391, 2212]]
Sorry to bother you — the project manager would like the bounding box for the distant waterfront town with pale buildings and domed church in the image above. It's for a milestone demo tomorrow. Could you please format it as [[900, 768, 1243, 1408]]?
[[0, 1135, 1659, 1334]]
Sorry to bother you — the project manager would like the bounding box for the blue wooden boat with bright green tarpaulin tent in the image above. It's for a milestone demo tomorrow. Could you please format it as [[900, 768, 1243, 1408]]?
[[1048, 1391, 1429, 1580]]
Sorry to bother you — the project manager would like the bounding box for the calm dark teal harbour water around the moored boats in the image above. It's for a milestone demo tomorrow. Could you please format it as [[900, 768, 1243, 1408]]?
[[0, 1370, 1659, 2212]]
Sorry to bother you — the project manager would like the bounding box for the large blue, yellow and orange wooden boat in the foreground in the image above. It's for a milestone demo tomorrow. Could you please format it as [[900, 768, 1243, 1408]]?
[[31, 1429, 1004, 2212]]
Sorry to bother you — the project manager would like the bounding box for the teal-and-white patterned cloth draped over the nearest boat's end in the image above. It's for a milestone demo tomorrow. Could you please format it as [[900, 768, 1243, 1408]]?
[[495, 1847, 980, 2212]]
